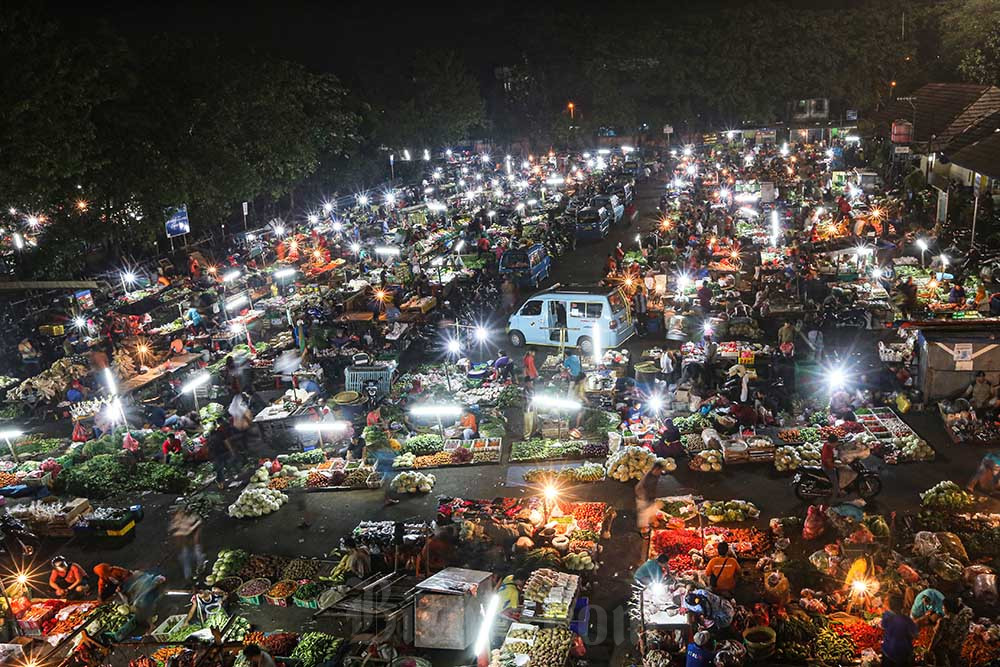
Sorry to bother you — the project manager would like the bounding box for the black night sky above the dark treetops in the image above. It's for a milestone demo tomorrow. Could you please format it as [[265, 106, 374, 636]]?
[[42, 0, 860, 80]]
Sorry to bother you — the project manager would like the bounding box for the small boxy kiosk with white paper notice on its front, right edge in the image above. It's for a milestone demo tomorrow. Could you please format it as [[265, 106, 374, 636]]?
[[913, 322, 1000, 401]]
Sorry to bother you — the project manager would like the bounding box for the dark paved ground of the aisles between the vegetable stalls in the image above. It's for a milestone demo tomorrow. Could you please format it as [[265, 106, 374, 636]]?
[[17, 174, 1000, 666]]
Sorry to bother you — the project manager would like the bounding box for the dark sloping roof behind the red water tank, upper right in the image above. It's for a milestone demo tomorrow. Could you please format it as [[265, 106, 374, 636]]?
[[872, 83, 1000, 143]]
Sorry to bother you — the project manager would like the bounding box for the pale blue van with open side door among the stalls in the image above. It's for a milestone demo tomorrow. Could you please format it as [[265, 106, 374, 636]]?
[[507, 285, 635, 354]]
